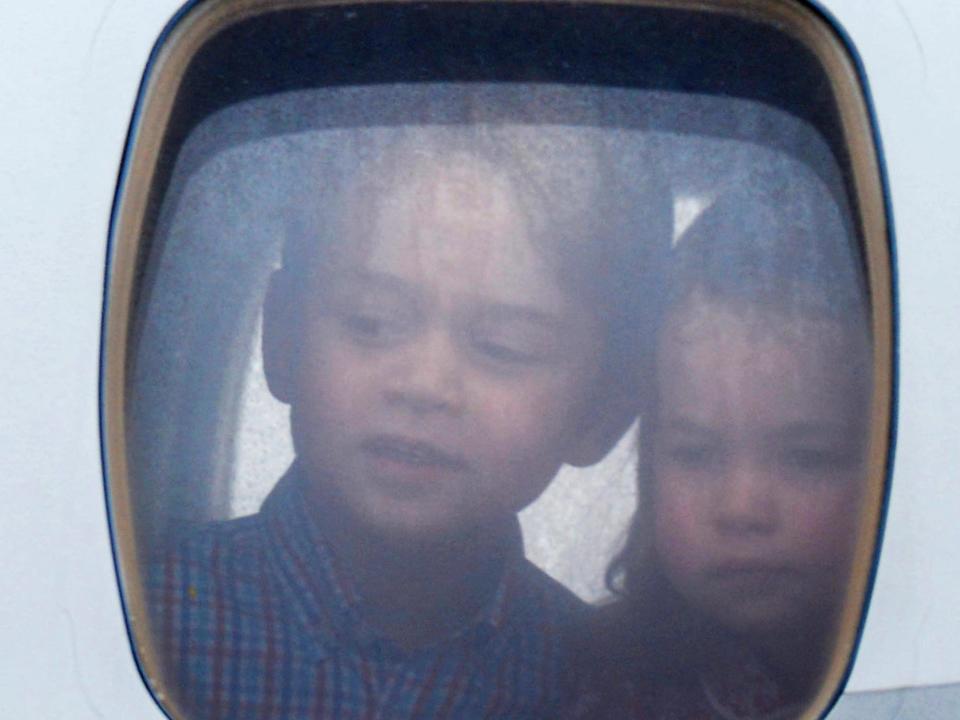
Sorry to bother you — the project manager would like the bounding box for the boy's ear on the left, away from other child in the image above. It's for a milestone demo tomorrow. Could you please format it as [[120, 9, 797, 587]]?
[[261, 270, 299, 404]]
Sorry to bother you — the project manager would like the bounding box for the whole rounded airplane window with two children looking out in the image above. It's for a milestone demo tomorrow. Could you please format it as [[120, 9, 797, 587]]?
[[103, 1, 892, 718]]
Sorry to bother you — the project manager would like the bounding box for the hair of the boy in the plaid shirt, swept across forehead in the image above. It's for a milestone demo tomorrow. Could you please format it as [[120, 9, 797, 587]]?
[[282, 124, 673, 414]]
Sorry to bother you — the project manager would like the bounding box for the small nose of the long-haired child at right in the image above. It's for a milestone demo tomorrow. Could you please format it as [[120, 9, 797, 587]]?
[[715, 461, 780, 535]]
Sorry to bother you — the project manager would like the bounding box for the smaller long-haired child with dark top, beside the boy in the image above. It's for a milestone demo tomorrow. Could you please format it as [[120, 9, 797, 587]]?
[[581, 183, 872, 718]]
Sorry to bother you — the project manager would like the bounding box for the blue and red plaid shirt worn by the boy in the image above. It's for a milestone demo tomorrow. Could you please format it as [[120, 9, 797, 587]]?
[[147, 478, 587, 717]]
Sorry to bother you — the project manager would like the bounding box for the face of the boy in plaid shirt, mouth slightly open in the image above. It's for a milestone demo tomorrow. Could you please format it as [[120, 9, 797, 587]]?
[[282, 157, 601, 536]]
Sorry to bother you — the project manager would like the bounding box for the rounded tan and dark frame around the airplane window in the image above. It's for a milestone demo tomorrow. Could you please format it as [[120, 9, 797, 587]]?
[[100, 0, 896, 718]]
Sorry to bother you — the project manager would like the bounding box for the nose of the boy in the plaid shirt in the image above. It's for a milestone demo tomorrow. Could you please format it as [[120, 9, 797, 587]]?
[[386, 329, 464, 415]]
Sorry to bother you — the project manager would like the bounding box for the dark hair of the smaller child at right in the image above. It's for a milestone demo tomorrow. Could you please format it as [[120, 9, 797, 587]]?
[[606, 184, 870, 678]]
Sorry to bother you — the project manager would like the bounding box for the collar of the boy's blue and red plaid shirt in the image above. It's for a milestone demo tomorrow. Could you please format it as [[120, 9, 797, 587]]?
[[260, 465, 525, 659]]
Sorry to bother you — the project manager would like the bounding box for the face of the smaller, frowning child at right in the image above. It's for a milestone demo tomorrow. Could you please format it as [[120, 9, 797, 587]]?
[[653, 300, 868, 637]]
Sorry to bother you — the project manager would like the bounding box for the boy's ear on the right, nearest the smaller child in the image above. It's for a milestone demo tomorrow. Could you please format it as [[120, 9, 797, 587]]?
[[564, 382, 640, 467]]
